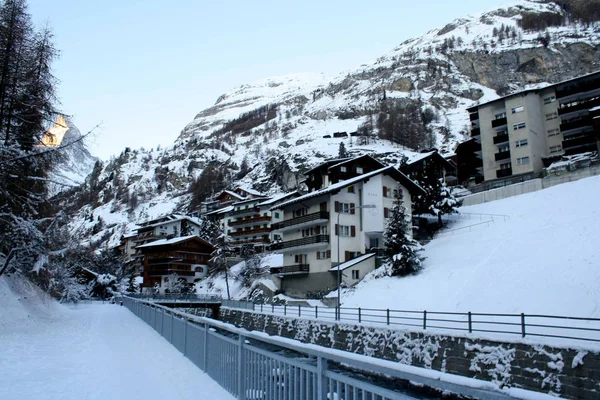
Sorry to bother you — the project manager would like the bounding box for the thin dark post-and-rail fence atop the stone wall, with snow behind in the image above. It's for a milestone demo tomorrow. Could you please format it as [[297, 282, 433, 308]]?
[[241, 304, 600, 342]]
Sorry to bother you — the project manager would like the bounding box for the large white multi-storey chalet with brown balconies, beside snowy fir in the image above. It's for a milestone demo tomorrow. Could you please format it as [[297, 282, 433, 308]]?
[[271, 156, 423, 297]]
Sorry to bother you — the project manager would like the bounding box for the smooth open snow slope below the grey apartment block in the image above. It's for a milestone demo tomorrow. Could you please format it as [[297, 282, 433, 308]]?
[[342, 177, 600, 318]]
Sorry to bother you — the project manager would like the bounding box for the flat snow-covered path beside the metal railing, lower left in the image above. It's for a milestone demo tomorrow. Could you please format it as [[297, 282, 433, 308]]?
[[0, 304, 233, 400]]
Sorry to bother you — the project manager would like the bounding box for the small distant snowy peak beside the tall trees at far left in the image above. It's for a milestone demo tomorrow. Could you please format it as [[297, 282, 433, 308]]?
[[50, 119, 98, 194]]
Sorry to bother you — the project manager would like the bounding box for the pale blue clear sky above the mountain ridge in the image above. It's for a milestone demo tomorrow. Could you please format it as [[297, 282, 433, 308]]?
[[29, 0, 504, 159]]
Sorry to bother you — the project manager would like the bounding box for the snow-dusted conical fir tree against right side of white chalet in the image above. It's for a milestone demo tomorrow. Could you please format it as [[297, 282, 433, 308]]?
[[384, 188, 424, 276]]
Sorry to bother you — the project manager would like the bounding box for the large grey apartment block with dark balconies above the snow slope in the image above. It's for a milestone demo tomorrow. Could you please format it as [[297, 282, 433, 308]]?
[[466, 72, 600, 181]]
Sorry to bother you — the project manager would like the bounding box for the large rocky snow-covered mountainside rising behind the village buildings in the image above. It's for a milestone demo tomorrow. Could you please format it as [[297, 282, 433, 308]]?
[[62, 0, 600, 245]]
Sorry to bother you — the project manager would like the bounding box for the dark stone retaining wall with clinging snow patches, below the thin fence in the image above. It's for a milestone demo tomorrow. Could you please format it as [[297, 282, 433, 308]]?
[[220, 308, 600, 399]]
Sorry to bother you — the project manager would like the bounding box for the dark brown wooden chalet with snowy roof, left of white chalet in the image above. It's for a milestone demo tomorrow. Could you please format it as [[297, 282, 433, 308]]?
[[137, 235, 214, 293]]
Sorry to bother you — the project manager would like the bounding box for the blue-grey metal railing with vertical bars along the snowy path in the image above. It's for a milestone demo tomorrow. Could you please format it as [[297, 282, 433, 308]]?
[[120, 297, 510, 400]]
